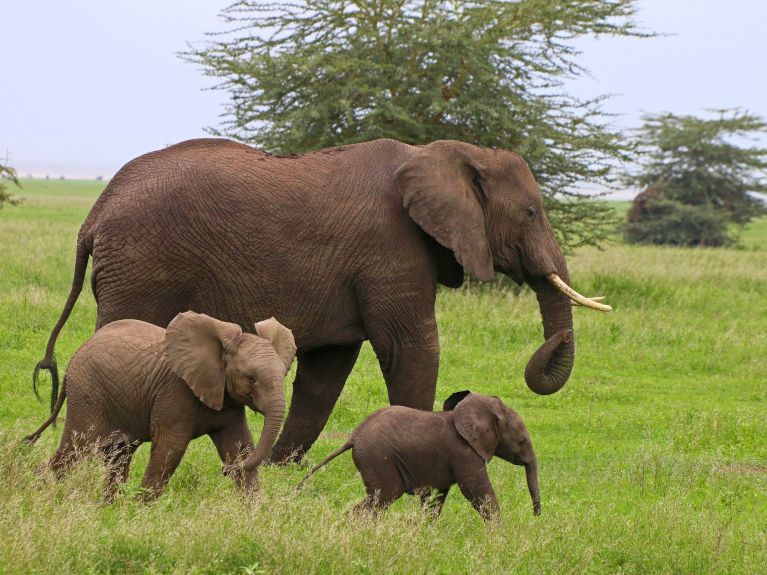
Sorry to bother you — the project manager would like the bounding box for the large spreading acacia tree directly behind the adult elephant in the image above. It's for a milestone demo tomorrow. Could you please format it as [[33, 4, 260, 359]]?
[[182, 0, 643, 251]]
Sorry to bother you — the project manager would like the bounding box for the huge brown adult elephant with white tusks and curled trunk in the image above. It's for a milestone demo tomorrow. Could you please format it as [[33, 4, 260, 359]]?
[[36, 139, 609, 461]]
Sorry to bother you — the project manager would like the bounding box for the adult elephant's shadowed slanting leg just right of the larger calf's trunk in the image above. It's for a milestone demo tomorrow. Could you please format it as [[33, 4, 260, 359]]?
[[271, 341, 362, 464]]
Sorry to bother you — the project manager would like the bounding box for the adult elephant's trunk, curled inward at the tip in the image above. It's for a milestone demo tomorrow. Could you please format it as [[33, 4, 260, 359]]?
[[525, 276, 575, 395]]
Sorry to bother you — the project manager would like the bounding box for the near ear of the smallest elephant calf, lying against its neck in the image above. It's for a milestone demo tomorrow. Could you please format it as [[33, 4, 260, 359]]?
[[453, 393, 501, 462]]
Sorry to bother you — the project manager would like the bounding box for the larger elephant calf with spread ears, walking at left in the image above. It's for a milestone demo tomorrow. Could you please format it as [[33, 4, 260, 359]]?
[[27, 311, 296, 501]]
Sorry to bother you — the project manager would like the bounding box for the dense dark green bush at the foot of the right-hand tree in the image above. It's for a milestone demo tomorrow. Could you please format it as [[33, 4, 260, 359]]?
[[623, 197, 731, 247]]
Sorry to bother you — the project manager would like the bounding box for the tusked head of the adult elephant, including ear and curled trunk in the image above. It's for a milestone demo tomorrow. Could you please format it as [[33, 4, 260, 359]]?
[[395, 141, 611, 395]]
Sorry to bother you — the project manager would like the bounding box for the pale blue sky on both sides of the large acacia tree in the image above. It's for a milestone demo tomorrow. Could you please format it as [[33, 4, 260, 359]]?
[[0, 0, 767, 177]]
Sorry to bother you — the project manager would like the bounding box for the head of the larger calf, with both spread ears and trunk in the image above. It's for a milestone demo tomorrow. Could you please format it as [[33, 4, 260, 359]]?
[[165, 311, 296, 471]]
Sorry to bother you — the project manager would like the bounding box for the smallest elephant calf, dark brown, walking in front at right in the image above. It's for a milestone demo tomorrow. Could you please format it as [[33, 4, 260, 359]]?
[[299, 391, 541, 519]]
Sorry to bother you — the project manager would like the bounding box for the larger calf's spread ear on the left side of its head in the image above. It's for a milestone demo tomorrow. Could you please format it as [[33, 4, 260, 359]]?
[[165, 311, 242, 410]]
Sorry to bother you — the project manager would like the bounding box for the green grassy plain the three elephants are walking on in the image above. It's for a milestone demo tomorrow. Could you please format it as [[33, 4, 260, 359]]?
[[0, 181, 767, 574]]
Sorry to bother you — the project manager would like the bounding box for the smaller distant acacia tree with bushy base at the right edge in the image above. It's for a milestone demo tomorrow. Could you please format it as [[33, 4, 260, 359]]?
[[624, 109, 767, 246]]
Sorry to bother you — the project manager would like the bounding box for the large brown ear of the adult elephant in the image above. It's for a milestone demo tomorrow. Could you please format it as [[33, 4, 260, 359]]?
[[394, 141, 493, 280]]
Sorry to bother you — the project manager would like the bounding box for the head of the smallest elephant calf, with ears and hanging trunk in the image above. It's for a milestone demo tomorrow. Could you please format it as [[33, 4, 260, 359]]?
[[445, 391, 541, 515]]
